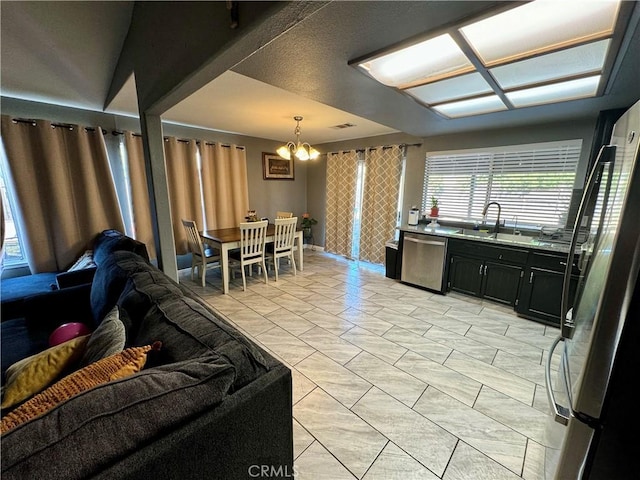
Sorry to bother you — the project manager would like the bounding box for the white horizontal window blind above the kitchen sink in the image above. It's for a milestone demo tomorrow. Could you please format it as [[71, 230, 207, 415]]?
[[422, 140, 582, 228]]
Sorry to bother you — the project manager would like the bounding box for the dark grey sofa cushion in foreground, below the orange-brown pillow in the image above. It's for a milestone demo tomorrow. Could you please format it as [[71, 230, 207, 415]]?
[[0, 353, 233, 480]]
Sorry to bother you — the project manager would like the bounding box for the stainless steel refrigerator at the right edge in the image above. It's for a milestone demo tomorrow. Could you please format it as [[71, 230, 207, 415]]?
[[545, 102, 640, 480]]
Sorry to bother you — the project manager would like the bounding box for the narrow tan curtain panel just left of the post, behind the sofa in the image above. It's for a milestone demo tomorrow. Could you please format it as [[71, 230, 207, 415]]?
[[124, 132, 156, 258]]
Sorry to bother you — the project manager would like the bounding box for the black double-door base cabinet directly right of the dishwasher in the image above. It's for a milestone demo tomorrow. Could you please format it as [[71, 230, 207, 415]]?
[[447, 242, 528, 306]]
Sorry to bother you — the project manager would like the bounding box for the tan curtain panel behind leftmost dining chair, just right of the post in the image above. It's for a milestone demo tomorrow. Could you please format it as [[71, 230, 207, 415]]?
[[164, 137, 203, 255]]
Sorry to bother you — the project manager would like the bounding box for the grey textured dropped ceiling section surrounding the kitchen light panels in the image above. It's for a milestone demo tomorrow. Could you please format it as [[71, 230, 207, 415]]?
[[234, 1, 640, 137]]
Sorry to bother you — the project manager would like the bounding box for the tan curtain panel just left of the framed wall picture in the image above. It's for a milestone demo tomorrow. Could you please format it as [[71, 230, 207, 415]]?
[[198, 141, 249, 230]]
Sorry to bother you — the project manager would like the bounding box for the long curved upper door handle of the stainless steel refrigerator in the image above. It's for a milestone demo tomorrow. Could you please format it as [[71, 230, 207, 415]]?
[[560, 145, 616, 338]]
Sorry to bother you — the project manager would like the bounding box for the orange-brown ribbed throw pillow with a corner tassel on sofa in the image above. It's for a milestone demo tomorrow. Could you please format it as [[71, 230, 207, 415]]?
[[0, 342, 162, 433]]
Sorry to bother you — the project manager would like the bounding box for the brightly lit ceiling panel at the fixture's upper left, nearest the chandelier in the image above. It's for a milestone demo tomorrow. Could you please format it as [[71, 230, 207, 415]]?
[[359, 34, 474, 88]]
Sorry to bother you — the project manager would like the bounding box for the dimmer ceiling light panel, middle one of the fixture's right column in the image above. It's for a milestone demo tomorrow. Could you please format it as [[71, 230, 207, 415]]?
[[489, 40, 611, 89]]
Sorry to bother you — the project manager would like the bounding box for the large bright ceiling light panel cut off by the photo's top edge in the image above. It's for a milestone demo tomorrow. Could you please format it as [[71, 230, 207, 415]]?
[[460, 0, 620, 66]]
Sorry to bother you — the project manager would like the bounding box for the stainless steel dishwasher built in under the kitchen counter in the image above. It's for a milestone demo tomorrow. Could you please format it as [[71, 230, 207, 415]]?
[[400, 233, 447, 293]]
